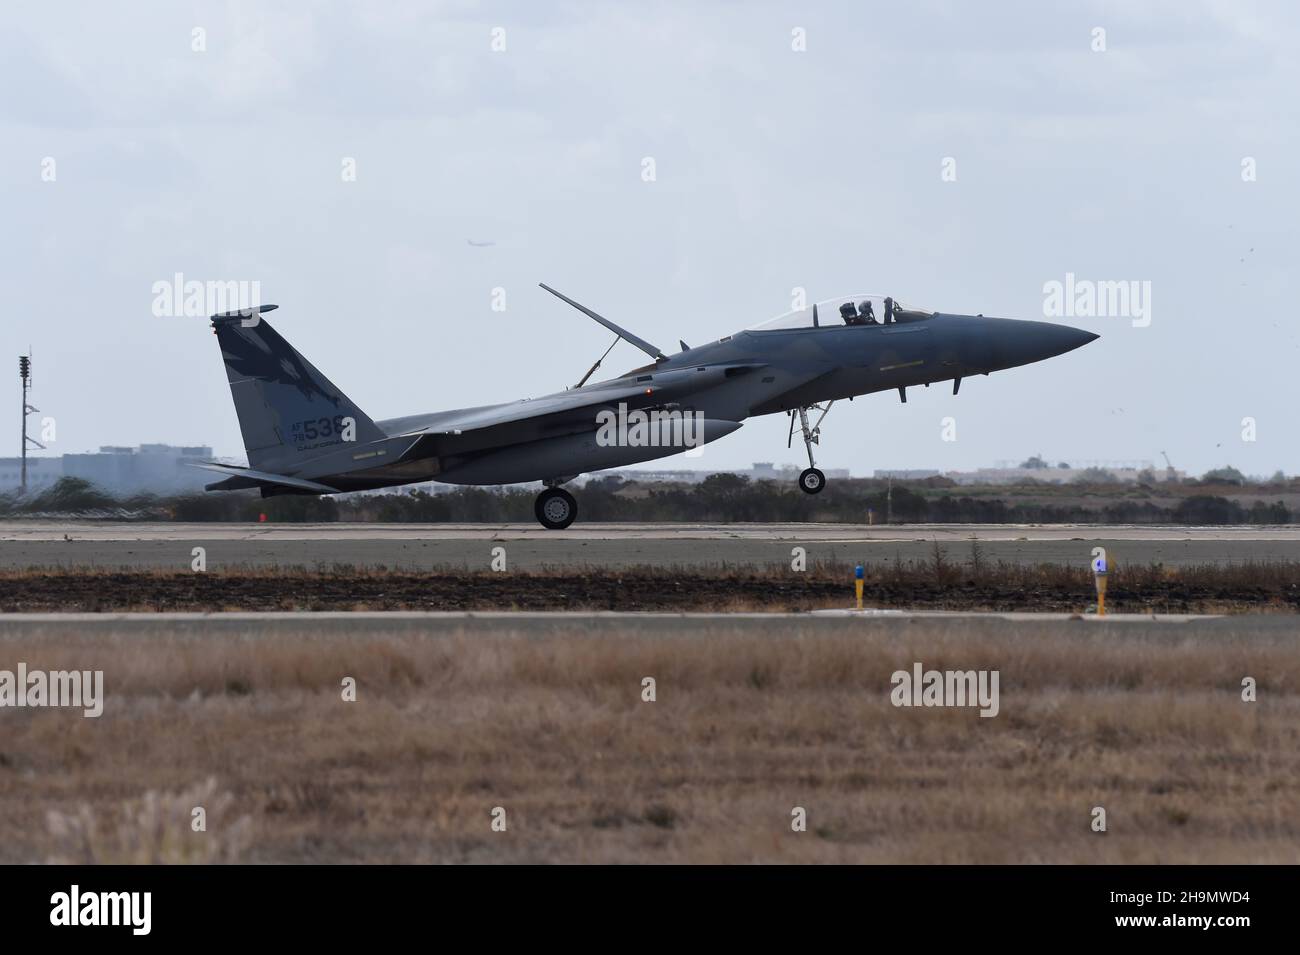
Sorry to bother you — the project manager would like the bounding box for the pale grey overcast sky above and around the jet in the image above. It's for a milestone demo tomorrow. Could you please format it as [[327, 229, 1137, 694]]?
[[0, 0, 1300, 474]]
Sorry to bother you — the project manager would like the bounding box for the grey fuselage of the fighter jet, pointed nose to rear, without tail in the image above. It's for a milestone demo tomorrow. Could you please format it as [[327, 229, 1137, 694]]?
[[356, 313, 1096, 487]]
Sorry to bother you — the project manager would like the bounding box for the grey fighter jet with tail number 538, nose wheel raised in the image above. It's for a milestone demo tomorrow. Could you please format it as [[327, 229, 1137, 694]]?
[[199, 285, 1097, 530]]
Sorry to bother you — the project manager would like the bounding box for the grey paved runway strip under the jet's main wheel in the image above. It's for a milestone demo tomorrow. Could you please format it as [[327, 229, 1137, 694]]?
[[0, 521, 1300, 570]]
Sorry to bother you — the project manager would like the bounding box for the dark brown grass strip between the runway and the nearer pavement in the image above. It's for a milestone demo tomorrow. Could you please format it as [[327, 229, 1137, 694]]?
[[0, 561, 1300, 613]]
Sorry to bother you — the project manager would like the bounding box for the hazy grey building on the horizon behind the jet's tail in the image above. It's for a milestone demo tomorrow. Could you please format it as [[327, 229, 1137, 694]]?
[[0, 444, 212, 495]]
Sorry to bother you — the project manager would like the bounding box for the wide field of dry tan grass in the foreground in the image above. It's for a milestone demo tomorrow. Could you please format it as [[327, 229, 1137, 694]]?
[[0, 616, 1300, 863]]
